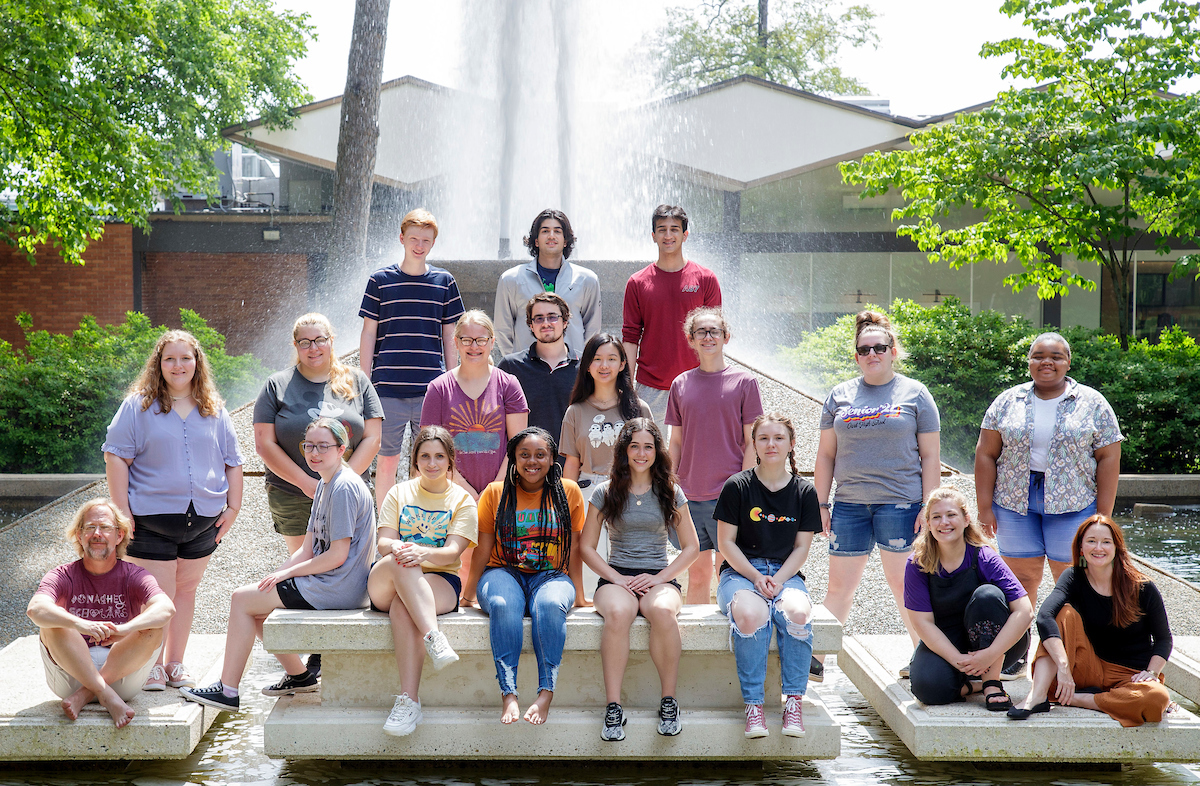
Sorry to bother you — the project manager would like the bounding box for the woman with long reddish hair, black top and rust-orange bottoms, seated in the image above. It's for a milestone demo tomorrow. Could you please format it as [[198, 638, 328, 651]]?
[[1008, 515, 1172, 726]]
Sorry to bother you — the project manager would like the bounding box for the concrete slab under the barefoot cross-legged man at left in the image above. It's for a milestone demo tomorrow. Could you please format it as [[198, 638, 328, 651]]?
[[0, 634, 224, 762]]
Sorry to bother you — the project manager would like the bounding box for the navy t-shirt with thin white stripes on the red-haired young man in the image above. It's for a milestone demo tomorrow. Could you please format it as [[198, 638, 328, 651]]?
[[359, 264, 463, 398]]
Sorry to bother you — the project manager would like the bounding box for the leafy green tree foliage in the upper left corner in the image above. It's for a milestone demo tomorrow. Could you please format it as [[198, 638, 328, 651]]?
[[0, 0, 310, 264]]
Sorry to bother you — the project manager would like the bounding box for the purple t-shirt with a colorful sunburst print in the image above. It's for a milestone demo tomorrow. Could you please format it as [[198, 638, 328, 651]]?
[[421, 368, 529, 492]]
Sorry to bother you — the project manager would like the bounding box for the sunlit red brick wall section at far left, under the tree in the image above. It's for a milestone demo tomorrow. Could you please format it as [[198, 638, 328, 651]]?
[[0, 224, 133, 347]]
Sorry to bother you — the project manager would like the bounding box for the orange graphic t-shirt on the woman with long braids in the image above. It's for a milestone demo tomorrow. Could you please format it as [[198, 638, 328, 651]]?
[[479, 478, 584, 572]]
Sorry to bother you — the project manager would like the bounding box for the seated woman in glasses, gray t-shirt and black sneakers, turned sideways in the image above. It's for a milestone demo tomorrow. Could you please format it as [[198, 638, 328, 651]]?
[[179, 418, 376, 712]]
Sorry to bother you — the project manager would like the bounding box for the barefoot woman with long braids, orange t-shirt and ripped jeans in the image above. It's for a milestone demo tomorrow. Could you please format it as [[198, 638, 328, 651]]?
[[467, 427, 583, 725]]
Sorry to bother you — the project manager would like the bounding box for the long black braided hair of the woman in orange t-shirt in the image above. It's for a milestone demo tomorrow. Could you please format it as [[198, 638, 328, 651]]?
[[496, 426, 571, 571]]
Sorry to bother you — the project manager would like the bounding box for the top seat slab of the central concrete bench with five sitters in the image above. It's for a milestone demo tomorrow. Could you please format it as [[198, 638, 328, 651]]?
[[263, 605, 841, 656]]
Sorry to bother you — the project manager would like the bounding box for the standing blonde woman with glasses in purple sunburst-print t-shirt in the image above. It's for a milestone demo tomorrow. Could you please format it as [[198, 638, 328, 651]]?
[[421, 308, 529, 604]]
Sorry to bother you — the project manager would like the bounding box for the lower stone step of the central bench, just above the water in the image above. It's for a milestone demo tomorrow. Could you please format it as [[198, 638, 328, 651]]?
[[263, 691, 841, 762]]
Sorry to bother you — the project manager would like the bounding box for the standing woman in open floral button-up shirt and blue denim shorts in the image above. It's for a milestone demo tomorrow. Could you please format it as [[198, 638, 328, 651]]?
[[976, 332, 1123, 673]]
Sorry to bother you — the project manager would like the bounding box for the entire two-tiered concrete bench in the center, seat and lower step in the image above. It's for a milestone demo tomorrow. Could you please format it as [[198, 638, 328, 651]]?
[[263, 605, 841, 761]]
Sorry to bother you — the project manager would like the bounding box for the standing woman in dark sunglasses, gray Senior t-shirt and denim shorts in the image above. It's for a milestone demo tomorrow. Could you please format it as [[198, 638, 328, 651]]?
[[814, 311, 941, 677]]
